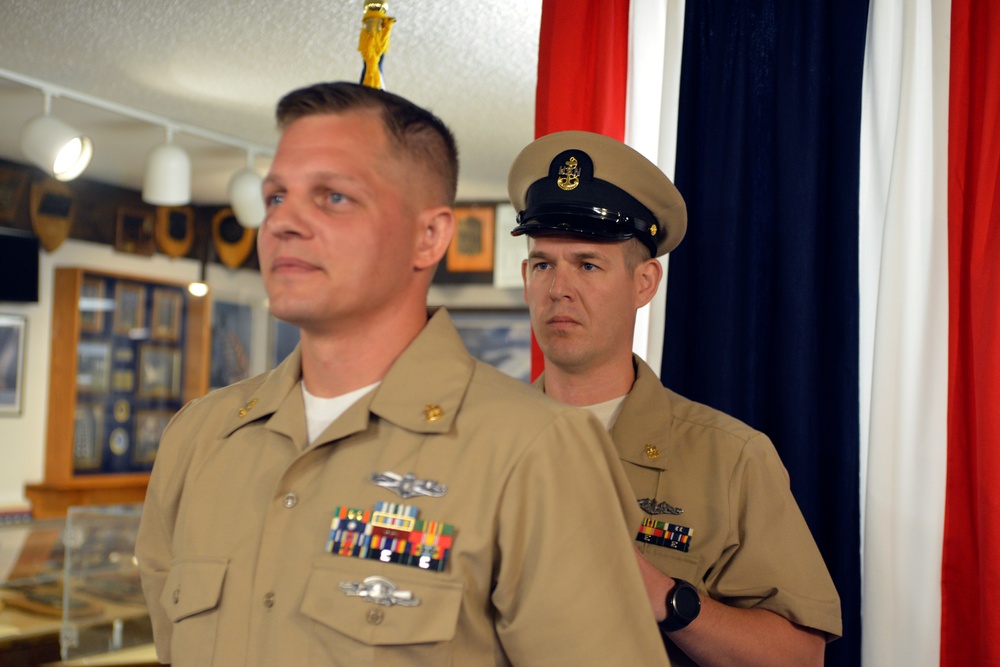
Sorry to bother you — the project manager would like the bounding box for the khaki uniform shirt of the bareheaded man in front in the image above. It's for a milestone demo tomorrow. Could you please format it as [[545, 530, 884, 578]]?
[[136, 309, 668, 667]]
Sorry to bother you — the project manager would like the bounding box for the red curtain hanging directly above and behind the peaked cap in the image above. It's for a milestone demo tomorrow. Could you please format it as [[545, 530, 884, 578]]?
[[531, 0, 629, 379]]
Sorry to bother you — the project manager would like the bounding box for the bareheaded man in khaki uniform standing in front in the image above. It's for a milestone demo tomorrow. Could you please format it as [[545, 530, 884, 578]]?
[[136, 83, 668, 667]]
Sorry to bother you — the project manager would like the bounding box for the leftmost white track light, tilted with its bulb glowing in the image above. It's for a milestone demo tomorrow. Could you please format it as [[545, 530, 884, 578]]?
[[21, 91, 94, 181]]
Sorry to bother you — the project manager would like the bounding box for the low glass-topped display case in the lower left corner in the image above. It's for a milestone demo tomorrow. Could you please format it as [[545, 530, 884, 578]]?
[[0, 505, 152, 665]]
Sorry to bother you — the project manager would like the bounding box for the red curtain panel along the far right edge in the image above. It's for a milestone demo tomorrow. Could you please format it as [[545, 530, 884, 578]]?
[[936, 0, 1000, 667]]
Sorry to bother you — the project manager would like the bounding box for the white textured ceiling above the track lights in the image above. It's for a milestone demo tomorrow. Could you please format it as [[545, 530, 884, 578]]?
[[0, 0, 541, 204]]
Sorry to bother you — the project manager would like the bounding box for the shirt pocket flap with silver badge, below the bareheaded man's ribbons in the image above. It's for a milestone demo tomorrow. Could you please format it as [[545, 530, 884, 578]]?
[[300, 556, 462, 646]]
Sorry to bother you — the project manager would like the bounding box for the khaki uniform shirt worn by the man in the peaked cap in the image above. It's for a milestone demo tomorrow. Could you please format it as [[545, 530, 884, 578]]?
[[536, 357, 842, 665]]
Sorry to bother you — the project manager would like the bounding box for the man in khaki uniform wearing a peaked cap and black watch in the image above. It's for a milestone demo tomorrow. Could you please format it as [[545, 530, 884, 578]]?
[[508, 132, 841, 667]]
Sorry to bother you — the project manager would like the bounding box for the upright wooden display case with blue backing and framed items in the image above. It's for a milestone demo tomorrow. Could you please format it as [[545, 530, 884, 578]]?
[[25, 268, 211, 518]]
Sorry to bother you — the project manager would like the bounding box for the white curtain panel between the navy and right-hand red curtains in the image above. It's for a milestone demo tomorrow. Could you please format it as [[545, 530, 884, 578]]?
[[859, 0, 950, 667]]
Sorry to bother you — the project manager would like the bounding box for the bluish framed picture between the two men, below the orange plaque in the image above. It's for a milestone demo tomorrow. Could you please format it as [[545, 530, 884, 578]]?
[[449, 310, 531, 382]]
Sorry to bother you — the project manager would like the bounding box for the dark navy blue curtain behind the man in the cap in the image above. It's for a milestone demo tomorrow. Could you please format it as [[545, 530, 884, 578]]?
[[662, 0, 868, 667]]
